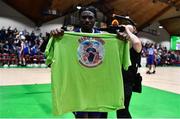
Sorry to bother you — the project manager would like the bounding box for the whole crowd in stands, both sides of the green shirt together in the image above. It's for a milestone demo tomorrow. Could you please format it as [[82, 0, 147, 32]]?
[[0, 27, 180, 67]]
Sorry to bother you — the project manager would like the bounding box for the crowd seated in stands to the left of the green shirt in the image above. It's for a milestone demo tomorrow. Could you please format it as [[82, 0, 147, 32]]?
[[0, 27, 49, 66]]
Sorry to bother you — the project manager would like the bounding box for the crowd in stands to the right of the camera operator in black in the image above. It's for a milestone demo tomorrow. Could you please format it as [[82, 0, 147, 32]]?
[[142, 42, 180, 66]]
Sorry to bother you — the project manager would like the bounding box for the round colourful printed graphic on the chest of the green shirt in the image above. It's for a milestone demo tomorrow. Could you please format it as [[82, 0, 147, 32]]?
[[78, 37, 104, 67]]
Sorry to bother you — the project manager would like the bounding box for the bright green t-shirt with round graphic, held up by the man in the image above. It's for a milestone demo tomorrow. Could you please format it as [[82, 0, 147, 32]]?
[[45, 32, 131, 115]]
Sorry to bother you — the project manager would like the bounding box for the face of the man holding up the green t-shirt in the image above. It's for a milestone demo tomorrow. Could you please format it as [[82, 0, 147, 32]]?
[[80, 11, 95, 30]]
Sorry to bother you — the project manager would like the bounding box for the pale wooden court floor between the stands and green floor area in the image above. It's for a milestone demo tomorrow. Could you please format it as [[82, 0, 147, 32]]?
[[0, 67, 180, 94]]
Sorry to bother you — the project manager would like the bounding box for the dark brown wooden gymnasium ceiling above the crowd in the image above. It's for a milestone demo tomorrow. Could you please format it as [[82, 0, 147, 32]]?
[[3, 0, 180, 35]]
